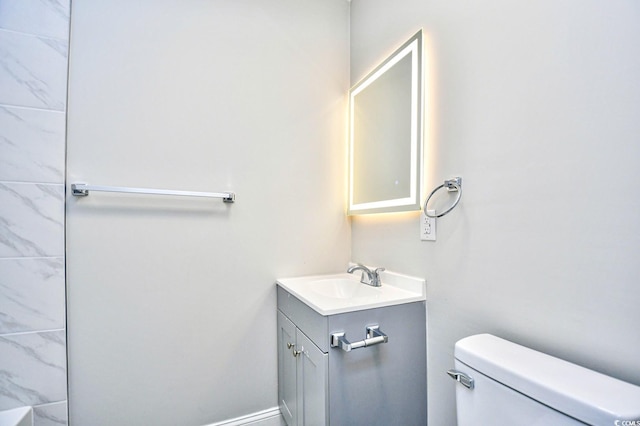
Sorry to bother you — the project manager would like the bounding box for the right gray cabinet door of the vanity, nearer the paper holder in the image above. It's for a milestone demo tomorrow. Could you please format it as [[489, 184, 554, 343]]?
[[296, 330, 329, 426]]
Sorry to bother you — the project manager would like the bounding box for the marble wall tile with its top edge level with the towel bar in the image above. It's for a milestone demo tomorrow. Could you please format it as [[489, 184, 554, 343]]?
[[0, 182, 64, 257]]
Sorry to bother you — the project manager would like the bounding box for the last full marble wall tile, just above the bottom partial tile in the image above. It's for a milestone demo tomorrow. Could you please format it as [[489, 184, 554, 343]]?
[[0, 330, 67, 410]]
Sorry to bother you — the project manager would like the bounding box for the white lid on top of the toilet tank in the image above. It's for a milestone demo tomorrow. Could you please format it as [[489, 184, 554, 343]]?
[[455, 334, 640, 425]]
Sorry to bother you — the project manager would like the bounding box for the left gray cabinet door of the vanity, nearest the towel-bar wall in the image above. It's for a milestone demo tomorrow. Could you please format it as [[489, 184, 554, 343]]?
[[278, 311, 302, 426]]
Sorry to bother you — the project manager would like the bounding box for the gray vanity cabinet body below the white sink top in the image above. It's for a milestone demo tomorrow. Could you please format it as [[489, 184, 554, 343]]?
[[277, 285, 427, 426]]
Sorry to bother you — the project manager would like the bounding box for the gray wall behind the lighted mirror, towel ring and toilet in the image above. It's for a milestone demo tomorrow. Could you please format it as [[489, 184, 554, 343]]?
[[351, 0, 640, 426]]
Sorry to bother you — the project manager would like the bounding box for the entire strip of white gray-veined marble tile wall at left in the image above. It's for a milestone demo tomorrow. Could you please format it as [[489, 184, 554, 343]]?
[[0, 0, 70, 426]]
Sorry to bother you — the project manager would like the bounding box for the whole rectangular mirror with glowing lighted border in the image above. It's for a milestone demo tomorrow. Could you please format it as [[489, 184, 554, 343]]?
[[348, 31, 422, 215]]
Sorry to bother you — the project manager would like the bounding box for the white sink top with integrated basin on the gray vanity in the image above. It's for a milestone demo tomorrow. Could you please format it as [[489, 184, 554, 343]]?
[[277, 271, 426, 315]]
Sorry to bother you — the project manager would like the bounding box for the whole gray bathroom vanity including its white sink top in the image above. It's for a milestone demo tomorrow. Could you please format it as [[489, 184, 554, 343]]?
[[277, 272, 427, 426]]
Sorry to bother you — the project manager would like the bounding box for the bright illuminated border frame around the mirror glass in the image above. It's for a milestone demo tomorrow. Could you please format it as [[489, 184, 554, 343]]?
[[347, 30, 423, 215]]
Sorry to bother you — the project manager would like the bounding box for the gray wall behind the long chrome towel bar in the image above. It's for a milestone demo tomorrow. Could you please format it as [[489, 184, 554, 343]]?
[[67, 0, 350, 425]]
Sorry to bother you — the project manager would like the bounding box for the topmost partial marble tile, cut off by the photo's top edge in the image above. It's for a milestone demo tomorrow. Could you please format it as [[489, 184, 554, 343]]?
[[0, 0, 69, 39]]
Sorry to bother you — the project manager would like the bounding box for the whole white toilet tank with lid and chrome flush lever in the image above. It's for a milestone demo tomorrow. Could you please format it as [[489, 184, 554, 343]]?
[[448, 334, 640, 426]]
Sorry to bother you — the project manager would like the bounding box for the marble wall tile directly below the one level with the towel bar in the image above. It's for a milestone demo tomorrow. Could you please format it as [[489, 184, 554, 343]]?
[[0, 257, 65, 334]]
